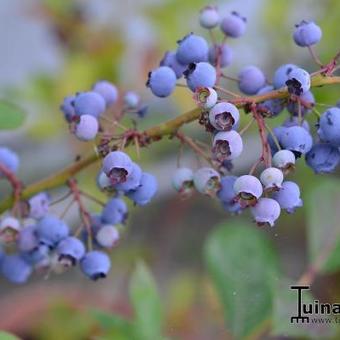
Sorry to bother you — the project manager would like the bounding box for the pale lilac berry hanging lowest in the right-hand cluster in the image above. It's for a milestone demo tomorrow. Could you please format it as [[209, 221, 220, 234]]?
[[251, 197, 281, 227]]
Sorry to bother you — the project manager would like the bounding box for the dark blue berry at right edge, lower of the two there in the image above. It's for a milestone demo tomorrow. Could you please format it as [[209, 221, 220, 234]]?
[[306, 143, 340, 174]]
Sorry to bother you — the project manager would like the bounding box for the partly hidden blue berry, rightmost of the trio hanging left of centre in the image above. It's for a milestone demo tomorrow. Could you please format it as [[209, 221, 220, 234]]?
[[126, 172, 158, 206]]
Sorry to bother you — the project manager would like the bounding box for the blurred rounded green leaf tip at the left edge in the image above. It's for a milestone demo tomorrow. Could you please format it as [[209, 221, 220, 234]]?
[[0, 100, 25, 130]]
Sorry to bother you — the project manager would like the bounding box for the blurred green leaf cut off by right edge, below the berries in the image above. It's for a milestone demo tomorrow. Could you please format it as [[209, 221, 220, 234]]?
[[306, 180, 340, 273]]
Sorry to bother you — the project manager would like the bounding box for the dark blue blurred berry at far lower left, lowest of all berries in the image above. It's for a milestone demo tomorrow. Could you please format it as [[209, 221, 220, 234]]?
[[1, 255, 32, 284]]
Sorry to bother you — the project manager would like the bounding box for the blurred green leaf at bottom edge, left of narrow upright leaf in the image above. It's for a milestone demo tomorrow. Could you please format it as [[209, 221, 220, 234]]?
[[90, 310, 134, 340]]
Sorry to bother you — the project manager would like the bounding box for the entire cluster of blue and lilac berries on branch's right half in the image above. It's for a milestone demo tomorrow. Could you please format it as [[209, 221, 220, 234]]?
[[147, 6, 340, 226]]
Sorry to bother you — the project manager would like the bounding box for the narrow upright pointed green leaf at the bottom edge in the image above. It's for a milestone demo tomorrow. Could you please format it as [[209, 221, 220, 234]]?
[[130, 262, 162, 340]]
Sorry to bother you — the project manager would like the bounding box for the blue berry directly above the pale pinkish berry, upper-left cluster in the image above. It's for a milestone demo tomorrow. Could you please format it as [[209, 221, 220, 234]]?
[[74, 91, 105, 118]]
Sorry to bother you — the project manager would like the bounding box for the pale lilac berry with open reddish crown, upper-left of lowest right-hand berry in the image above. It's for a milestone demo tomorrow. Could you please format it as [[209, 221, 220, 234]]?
[[234, 175, 263, 207]]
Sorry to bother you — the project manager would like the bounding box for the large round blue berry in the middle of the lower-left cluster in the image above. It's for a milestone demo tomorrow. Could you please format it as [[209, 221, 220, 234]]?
[[36, 215, 69, 248]]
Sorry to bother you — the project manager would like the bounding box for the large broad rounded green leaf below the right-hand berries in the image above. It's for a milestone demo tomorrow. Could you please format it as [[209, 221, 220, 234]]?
[[204, 222, 278, 339]]
